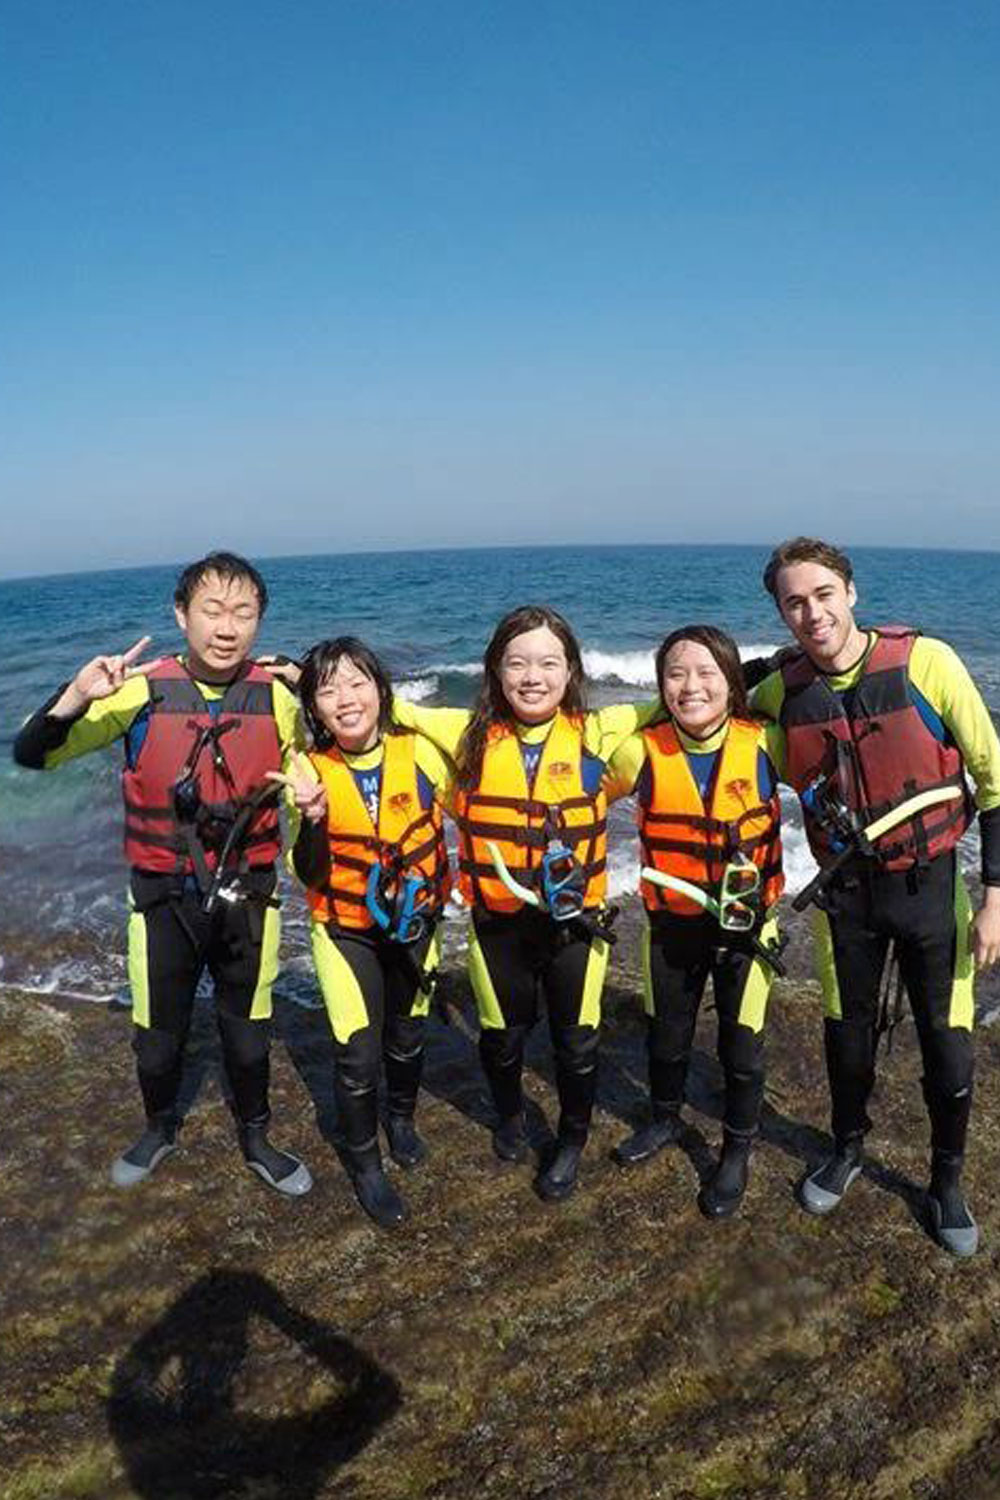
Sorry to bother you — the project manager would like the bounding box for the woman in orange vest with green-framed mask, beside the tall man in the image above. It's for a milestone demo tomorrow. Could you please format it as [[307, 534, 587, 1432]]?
[[607, 626, 783, 1218]]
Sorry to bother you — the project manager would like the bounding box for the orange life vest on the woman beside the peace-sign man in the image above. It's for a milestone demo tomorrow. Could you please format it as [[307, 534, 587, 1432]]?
[[306, 734, 450, 930]]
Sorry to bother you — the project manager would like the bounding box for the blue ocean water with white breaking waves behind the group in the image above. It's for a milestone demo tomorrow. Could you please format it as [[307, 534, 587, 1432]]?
[[0, 546, 1000, 1004]]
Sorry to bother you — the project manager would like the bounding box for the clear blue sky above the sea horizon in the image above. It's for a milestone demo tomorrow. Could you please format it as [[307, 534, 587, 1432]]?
[[0, 0, 1000, 576]]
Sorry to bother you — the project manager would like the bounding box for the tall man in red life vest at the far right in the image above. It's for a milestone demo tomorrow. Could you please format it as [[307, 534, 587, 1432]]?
[[753, 537, 1000, 1256]]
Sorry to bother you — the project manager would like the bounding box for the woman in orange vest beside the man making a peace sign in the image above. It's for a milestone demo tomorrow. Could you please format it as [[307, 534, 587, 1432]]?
[[275, 636, 450, 1227]]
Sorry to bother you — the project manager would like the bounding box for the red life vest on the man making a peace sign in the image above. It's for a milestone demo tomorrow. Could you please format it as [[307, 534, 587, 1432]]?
[[121, 659, 282, 875]]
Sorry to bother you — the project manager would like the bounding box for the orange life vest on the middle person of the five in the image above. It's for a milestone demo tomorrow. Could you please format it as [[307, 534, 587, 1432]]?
[[456, 713, 607, 914]]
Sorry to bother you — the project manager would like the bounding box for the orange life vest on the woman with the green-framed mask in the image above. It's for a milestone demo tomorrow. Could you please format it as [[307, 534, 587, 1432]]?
[[637, 719, 784, 917]]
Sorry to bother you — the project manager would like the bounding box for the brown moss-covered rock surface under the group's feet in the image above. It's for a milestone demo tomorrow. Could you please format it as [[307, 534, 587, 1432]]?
[[0, 911, 1000, 1500]]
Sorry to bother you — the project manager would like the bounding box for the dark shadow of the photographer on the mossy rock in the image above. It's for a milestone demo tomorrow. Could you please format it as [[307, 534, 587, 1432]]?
[[108, 1271, 400, 1500]]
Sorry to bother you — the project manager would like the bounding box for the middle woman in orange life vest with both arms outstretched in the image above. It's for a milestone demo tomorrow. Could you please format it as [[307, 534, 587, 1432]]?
[[396, 606, 660, 1202]]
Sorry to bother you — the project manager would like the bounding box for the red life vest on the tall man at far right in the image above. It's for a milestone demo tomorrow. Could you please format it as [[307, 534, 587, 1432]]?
[[781, 626, 973, 870]]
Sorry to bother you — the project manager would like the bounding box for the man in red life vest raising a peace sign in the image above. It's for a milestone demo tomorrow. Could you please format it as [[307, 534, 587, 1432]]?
[[13, 552, 312, 1196]]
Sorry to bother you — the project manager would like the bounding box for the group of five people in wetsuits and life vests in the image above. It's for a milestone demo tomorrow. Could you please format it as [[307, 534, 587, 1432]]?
[[15, 537, 1000, 1256]]
